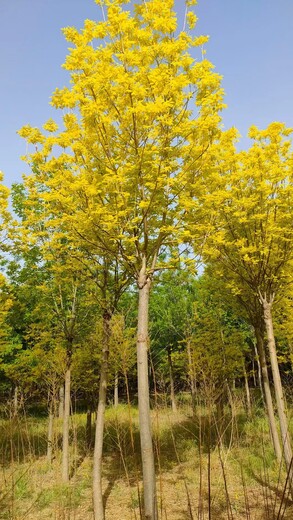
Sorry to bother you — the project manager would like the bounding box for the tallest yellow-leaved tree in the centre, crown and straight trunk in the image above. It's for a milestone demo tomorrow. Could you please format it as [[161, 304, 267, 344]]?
[[20, 0, 223, 520]]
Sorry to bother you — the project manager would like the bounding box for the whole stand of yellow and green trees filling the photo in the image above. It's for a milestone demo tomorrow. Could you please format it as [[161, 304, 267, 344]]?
[[0, 0, 293, 520]]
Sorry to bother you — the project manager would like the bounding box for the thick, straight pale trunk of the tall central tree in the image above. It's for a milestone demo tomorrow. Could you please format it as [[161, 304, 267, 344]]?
[[137, 268, 157, 520]]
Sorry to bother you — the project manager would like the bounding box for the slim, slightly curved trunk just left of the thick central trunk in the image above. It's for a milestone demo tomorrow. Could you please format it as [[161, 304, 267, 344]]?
[[93, 312, 111, 520]]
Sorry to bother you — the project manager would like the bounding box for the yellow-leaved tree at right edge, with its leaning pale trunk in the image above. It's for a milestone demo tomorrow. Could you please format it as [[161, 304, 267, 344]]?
[[207, 123, 293, 478]]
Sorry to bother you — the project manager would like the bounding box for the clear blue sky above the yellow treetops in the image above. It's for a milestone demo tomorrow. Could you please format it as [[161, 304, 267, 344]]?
[[0, 0, 293, 185]]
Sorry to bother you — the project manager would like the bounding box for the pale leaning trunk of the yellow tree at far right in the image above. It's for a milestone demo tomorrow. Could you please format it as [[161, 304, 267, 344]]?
[[261, 297, 293, 472]]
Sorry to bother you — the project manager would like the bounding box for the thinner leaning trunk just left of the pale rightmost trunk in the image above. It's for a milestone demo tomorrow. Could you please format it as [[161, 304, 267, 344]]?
[[254, 327, 282, 462]]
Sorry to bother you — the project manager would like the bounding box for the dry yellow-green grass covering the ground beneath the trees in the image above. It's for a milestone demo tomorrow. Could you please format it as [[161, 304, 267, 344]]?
[[0, 402, 293, 520]]
